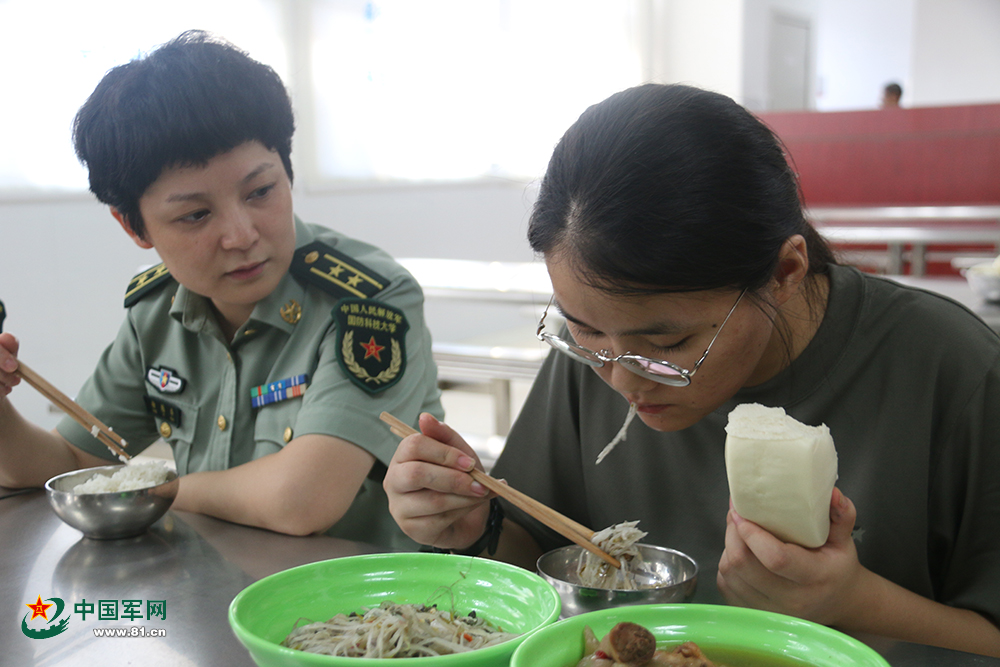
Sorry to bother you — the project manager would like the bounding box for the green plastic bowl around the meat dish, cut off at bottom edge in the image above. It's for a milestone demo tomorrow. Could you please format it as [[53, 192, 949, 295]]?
[[510, 604, 889, 667]]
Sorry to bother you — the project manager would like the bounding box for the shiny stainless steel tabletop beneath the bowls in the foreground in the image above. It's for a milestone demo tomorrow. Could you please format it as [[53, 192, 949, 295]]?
[[0, 488, 1000, 667]]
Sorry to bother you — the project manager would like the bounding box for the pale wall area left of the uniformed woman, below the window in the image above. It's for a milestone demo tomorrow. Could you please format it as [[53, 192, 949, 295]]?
[[0, 197, 152, 427]]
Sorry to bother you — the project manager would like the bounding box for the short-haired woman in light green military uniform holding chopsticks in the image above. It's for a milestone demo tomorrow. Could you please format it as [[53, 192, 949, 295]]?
[[0, 31, 443, 549]]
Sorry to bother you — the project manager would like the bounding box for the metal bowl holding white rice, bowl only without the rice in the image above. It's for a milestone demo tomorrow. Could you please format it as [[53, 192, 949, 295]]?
[[45, 465, 180, 540]]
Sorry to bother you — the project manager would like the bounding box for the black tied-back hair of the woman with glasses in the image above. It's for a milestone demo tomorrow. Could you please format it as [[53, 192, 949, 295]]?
[[528, 84, 836, 294]]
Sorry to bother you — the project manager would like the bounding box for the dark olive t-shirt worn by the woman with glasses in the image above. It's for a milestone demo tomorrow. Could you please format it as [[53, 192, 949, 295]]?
[[493, 267, 1000, 623]]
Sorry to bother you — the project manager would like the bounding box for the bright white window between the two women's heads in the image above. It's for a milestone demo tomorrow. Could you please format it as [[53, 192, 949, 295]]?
[[310, 0, 642, 180]]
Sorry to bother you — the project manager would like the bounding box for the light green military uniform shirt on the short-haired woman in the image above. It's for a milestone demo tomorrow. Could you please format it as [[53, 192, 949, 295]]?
[[58, 219, 443, 550]]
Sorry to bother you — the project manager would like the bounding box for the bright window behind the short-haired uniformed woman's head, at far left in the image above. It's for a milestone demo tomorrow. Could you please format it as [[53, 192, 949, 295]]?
[[0, 0, 287, 192]]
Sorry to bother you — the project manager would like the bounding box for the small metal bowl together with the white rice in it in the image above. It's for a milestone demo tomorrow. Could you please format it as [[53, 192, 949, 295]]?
[[45, 460, 180, 540]]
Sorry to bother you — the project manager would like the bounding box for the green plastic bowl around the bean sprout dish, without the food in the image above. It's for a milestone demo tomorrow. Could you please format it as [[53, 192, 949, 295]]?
[[229, 553, 561, 667]]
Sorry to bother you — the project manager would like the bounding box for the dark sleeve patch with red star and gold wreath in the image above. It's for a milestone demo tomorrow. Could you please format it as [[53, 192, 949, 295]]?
[[333, 298, 410, 394]]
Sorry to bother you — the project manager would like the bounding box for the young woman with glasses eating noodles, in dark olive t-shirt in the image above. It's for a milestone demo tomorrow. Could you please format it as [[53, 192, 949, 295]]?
[[384, 84, 1000, 655]]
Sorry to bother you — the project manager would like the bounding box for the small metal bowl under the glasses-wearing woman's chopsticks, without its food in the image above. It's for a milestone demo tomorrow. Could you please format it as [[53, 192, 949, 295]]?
[[536, 544, 698, 618]]
